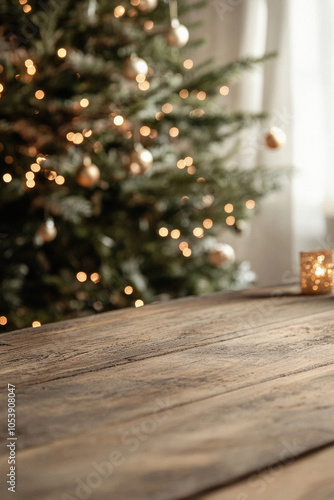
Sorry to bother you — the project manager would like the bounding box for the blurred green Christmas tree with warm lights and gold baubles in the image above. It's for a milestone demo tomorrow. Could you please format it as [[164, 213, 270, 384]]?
[[0, 0, 279, 331]]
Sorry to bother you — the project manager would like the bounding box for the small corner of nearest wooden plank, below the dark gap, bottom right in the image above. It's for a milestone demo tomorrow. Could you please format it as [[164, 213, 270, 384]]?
[[194, 446, 334, 500]]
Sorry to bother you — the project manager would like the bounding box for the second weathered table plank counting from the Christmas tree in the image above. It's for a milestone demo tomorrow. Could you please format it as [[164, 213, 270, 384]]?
[[0, 304, 334, 454]]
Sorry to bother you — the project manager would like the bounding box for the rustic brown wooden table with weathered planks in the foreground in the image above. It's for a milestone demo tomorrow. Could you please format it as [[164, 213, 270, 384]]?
[[0, 289, 334, 500]]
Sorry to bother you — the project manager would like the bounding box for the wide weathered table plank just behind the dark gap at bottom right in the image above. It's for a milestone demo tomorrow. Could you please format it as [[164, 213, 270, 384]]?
[[0, 366, 334, 500]]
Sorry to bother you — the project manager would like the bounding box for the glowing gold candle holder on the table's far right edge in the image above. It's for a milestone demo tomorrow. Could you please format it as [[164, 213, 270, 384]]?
[[300, 250, 334, 294]]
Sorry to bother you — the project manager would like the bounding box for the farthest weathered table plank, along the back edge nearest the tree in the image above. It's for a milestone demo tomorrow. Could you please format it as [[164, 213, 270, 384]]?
[[0, 289, 333, 389]]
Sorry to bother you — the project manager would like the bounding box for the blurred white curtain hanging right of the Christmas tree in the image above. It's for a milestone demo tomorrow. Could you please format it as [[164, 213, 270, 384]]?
[[189, 0, 334, 285]]
